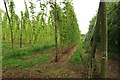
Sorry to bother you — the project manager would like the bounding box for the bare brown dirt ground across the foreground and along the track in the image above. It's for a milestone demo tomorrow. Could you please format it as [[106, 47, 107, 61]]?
[[2, 44, 118, 78]]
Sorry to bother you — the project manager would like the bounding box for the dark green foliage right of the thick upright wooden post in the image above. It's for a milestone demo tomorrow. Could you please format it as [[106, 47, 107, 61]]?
[[107, 2, 120, 60]]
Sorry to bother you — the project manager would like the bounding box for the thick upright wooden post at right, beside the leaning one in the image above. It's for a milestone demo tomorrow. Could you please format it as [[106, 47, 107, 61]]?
[[100, 2, 108, 78]]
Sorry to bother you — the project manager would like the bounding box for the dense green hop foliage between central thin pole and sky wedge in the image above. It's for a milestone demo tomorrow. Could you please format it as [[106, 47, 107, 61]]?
[[60, 0, 80, 46]]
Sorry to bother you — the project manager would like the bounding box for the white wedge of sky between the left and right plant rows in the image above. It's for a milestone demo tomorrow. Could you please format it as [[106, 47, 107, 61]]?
[[73, 0, 100, 34]]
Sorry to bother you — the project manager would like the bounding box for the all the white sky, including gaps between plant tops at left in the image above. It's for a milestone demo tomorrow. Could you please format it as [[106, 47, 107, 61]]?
[[0, 0, 100, 34]]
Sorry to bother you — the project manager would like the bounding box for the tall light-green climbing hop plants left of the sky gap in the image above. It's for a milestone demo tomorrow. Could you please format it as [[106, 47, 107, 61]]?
[[0, 0, 80, 61]]
